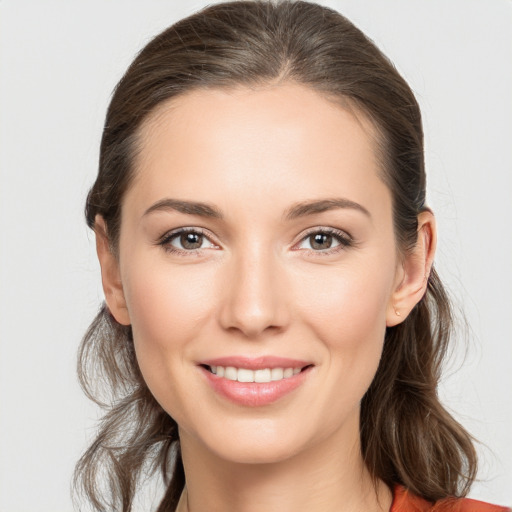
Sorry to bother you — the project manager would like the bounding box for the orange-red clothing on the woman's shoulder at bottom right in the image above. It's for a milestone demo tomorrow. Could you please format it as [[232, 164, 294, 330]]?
[[390, 485, 512, 512]]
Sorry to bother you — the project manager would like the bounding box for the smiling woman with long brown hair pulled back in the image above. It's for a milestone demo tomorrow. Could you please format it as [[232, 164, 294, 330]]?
[[76, 2, 510, 512]]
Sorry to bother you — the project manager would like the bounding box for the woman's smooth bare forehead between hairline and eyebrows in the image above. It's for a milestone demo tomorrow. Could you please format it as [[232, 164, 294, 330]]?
[[127, 84, 387, 219]]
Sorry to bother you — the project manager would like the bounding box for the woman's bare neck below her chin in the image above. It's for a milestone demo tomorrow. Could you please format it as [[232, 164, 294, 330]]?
[[177, 418, 392, 512]]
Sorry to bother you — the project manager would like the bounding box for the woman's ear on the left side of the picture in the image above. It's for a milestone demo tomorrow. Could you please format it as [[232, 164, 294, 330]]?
[[94, 215, 130, 325]]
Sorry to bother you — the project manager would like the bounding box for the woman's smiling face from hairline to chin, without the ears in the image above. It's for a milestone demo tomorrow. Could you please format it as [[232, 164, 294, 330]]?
[[105, 84, 403, 462]]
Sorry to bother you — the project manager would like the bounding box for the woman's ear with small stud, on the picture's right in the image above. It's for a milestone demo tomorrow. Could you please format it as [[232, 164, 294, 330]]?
[[386, 210, 437, 327]]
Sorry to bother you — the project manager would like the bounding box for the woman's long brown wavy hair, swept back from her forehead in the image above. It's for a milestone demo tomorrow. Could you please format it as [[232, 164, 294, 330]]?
[[74, 0, 476, 512]]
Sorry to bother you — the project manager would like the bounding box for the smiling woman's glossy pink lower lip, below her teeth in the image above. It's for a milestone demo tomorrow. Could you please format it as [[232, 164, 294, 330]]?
[[200, 367, 311, 407]]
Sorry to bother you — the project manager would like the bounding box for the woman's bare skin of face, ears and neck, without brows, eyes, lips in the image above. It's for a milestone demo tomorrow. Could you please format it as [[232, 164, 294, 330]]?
[[96, 83, 435, 512]]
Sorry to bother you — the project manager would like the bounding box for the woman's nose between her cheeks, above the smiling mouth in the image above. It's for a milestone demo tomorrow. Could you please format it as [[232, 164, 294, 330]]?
[[220, 241, 289, 339]]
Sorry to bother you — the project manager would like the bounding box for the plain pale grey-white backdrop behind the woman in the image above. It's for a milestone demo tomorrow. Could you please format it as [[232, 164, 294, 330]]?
[[0, 0, 512, 512]]
